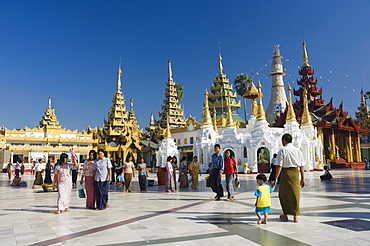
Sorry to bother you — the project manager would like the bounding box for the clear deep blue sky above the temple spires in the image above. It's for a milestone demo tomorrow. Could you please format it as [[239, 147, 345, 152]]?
[[0, 0, 370, 130]]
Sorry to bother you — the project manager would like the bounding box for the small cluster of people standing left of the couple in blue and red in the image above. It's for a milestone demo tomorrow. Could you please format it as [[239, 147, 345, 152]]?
[[165, 156, 201, 192]]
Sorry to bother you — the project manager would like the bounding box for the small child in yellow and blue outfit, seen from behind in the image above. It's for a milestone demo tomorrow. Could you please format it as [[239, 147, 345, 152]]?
[[254, 173, 273, 225]]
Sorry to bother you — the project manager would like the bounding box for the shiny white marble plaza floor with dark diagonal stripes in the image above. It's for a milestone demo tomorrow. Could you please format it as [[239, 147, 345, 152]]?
[[0, 169, 370, 246]]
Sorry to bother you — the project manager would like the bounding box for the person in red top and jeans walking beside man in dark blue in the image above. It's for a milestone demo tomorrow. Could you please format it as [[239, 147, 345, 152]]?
[[224, 149, 238, 201]]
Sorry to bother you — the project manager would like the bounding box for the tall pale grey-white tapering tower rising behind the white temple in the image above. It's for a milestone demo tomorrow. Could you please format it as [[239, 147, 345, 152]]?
[[266, 45, 288, 125]]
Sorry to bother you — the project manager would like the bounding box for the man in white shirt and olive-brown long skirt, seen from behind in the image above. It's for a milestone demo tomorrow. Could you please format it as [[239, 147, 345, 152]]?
[[272, 134, 305, 222]]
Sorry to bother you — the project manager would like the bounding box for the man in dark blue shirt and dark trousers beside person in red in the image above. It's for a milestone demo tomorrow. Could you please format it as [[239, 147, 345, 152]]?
[[209, 144, 224, 201]]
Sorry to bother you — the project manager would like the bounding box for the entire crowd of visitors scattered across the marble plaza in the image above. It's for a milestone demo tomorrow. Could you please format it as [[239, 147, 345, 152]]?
[[6, 134, 332, 224]]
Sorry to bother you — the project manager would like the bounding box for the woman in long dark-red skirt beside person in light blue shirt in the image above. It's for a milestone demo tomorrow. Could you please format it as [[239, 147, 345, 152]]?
[[80, 150, 97, 209]]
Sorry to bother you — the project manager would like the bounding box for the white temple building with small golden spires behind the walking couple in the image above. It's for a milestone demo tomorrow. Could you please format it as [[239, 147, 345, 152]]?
[[168, 47, 323, 173]]
